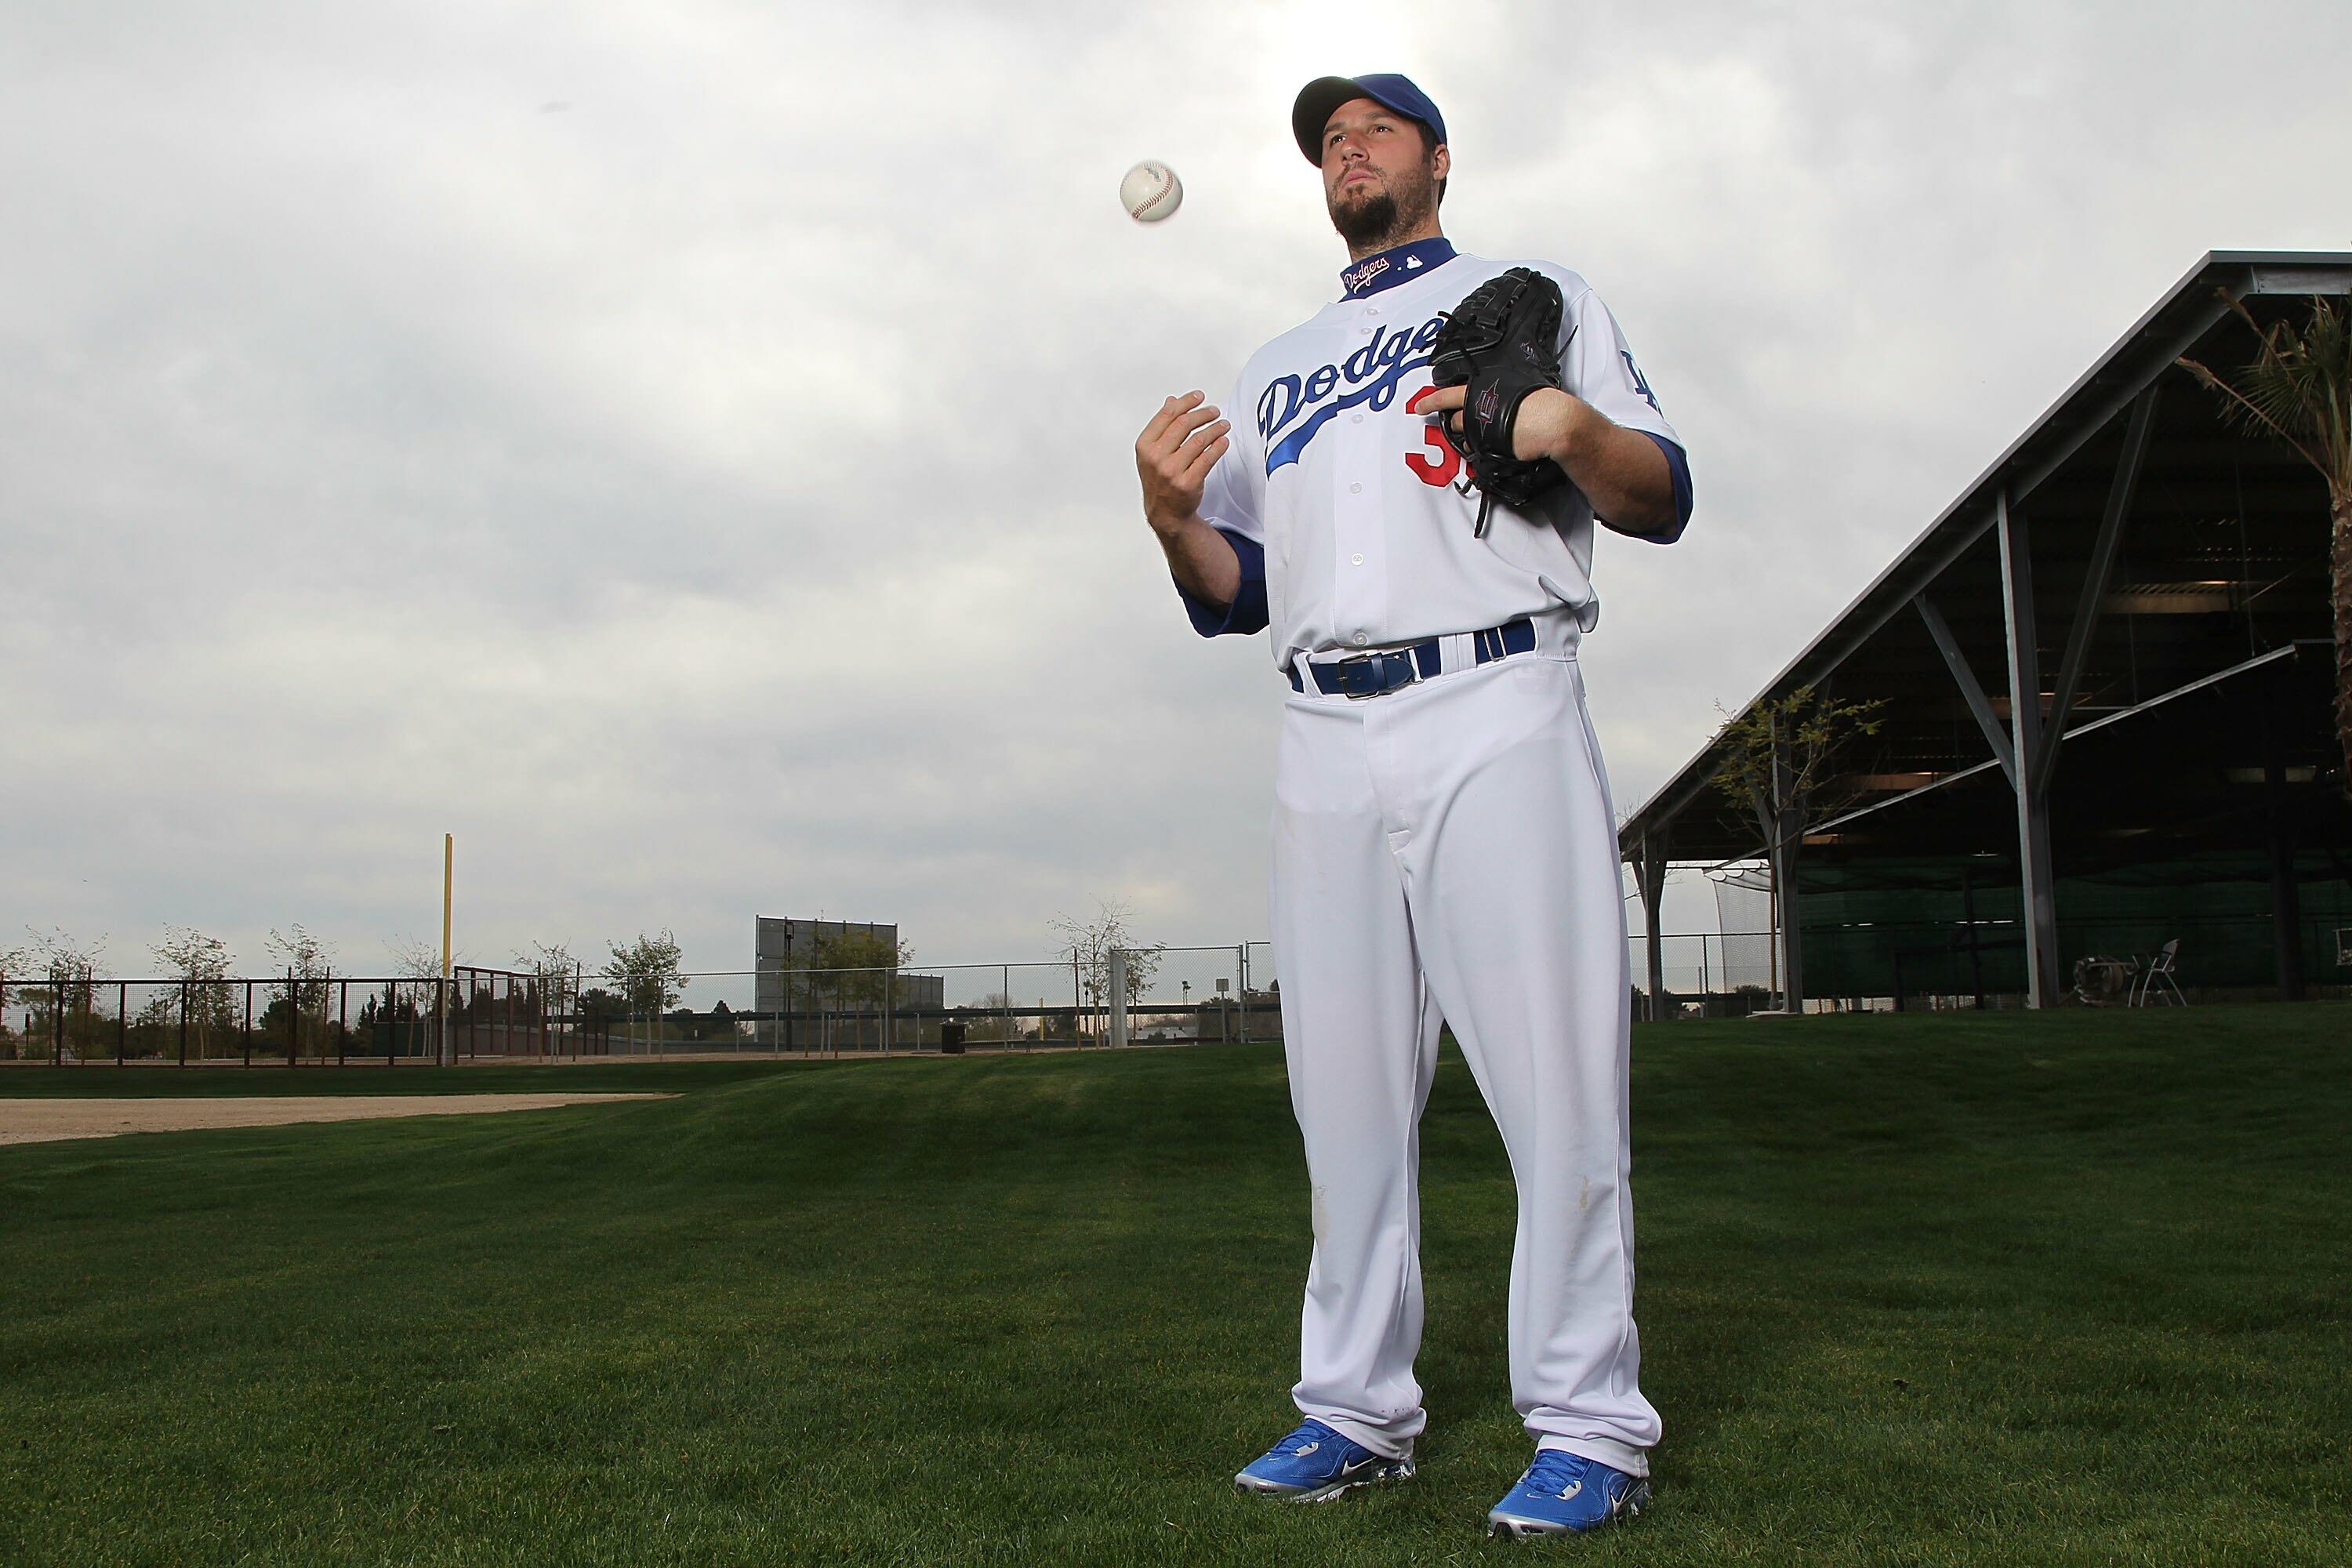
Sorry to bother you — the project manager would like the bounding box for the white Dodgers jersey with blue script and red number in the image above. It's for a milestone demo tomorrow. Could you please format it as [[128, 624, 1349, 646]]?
[[1188, 238, 1691, 668]]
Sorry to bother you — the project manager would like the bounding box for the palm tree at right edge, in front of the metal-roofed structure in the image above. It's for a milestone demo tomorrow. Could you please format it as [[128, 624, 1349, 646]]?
[[2180, 292, 2352, 797]]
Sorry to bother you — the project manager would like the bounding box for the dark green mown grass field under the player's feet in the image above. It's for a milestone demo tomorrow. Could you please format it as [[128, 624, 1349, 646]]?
[[0, 1004, 2352, 1568]]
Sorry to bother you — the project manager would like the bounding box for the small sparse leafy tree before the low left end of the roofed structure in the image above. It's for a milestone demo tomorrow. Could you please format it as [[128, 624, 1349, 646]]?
[[1715, 687, 1886, 1013]]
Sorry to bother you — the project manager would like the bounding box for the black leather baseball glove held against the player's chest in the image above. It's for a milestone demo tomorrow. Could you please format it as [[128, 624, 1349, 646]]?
[[1430, 266, 1573, 539]]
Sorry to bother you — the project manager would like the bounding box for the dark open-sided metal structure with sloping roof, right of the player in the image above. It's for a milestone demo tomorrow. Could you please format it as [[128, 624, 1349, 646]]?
[[1618, 252, 2352, 1018]]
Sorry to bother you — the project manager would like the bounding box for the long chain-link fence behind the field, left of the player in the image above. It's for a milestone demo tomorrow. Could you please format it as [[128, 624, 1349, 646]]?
[[0, 942, 1282, 1067]]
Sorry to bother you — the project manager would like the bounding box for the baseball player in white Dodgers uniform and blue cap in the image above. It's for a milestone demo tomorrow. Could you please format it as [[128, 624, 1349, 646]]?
[[1136, 75, 1691, 1535]]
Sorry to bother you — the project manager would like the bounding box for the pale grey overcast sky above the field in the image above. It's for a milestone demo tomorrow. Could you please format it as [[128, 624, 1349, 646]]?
[[0, 0, 2352, 1001]]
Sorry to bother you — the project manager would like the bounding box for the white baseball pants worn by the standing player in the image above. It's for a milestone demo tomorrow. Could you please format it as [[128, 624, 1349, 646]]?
[[1272, 652, 1658, 1474]]
